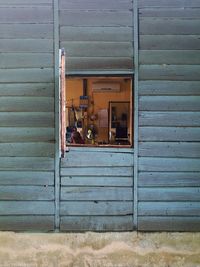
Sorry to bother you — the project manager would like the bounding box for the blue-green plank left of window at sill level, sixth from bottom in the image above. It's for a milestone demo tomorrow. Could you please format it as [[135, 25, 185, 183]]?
[[0, 142, 55, 157]]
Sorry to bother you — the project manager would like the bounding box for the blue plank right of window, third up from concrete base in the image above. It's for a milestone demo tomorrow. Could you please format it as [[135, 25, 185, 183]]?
[[138, 187, 200, 201]]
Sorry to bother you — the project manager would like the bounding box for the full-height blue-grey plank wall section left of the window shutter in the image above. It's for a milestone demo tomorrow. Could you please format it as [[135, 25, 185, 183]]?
[[0, 0, 55, 231]]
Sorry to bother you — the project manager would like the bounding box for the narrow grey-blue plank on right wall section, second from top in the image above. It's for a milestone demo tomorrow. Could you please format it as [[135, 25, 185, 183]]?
[[139, 7, 200, 19]]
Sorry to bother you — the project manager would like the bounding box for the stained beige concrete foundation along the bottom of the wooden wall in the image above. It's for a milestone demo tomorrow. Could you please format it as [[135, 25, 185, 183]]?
[[0, 232, 200, 267]]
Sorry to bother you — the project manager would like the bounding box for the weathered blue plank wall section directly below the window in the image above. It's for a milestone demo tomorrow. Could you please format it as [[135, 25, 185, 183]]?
[[60, 148, 133, 231]]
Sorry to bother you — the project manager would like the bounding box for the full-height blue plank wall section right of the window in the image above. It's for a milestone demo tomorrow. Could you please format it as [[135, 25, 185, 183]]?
[[138, 0, 200, 231]]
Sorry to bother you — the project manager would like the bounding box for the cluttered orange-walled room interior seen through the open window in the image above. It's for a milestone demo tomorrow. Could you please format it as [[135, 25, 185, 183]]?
[[65, 77, 133, 146]]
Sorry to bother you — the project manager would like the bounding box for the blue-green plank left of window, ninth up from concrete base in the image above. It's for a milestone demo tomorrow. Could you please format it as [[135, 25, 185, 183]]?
[[0, 96, 54, 112]]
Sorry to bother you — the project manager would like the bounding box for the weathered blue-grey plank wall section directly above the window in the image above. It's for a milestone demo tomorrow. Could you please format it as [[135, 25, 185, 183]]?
[[59, 0, 133, 74]]
